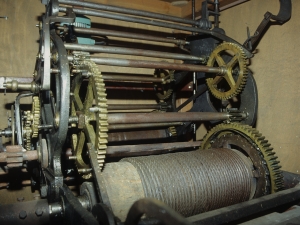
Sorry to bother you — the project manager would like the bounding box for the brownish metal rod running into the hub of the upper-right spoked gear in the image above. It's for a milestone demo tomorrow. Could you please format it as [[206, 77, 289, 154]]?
[[68, 56, 226, 75]]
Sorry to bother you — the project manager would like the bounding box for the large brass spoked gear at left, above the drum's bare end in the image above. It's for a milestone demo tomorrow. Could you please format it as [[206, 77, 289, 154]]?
[[71, 60, 108, 179]]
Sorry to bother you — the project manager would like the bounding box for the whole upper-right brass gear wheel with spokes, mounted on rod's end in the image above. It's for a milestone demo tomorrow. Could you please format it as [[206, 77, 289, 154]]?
[[206, 42, 248, 100]]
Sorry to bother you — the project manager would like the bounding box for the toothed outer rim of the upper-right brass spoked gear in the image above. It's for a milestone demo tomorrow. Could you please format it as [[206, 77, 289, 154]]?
[[206, 42, 248, 100]]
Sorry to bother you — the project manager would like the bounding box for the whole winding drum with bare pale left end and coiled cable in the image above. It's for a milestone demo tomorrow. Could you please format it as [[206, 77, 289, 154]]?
[[103, 149, 256, 220]]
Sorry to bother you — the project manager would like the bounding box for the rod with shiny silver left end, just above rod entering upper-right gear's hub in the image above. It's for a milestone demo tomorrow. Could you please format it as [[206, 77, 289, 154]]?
[[65, 43, 204, 61]]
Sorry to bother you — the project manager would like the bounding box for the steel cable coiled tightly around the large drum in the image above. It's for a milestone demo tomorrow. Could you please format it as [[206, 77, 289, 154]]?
[[121, 149, 255, 216]]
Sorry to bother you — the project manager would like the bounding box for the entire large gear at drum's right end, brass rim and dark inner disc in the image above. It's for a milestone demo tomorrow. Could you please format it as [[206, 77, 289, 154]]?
[[200, 123, 283, 194]]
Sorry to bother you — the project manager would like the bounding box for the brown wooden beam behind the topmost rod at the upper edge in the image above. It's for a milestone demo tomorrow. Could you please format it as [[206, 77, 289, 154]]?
[[90, 0, 181, 17]]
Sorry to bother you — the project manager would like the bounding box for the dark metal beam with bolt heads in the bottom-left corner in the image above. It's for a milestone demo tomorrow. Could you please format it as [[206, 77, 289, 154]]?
[[0, 199, 50, 225]]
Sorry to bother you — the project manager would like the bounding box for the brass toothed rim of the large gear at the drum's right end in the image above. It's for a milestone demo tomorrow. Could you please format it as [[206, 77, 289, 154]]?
[[200, 123, 283, 193]]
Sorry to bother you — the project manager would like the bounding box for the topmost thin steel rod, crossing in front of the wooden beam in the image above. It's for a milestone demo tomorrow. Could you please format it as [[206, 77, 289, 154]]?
[[58, 0, 197, 25]]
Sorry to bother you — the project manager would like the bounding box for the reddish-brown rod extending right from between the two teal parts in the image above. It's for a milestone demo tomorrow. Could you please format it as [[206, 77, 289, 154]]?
[[74, 27, 189, 45]]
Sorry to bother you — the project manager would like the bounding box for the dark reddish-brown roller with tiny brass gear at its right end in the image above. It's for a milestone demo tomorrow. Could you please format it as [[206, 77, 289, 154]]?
[[107, 129, 169, 142]]
